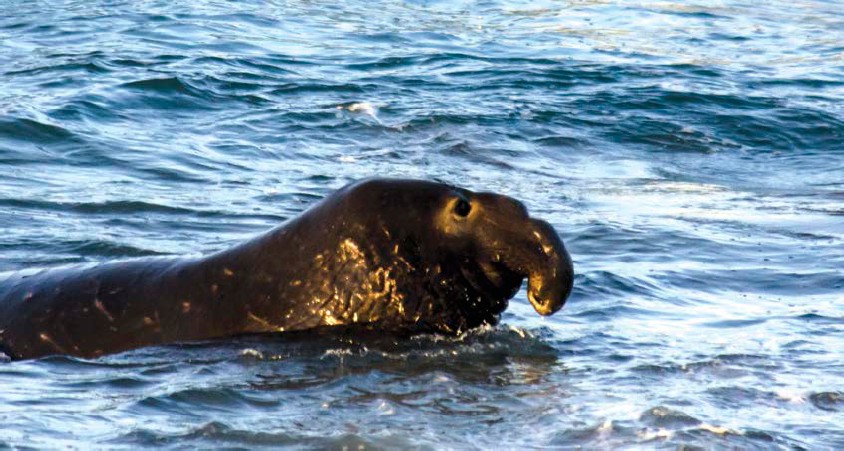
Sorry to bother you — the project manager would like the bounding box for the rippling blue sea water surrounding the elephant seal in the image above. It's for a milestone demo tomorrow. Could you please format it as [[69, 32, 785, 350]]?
[[0, 0, 844, 449]]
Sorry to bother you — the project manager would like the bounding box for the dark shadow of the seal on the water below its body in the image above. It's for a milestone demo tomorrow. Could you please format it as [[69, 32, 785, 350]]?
[[82, 326, 564, 390]]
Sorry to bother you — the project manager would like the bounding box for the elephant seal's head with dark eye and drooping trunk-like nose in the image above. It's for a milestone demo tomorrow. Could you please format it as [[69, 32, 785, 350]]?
[[314, 179, 574, 332]]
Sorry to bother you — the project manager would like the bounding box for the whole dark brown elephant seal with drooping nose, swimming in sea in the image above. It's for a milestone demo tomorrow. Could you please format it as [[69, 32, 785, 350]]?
[[0, 179, 573, 359]]
